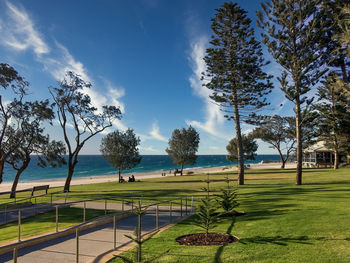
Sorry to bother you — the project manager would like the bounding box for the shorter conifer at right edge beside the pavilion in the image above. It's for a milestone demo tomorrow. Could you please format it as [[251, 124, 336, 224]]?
[[315, 77, 350, 169]]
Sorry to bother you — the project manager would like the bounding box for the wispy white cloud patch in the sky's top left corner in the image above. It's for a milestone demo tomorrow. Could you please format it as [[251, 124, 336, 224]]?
[[0, 1, 50, 56]]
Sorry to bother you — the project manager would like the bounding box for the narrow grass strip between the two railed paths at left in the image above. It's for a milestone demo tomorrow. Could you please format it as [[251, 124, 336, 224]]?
[[0, 208, 111, 245]]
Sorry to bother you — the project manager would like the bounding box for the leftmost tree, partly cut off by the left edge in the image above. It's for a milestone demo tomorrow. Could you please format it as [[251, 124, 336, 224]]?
[[0, 63, 29, 183]]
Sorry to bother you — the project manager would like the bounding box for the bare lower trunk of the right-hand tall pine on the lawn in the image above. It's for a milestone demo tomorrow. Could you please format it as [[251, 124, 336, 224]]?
[[295, 96, 303, 185]]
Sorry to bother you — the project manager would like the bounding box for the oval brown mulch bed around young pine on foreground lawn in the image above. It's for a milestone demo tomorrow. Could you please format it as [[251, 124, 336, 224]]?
[[176, 233, 239, 246]]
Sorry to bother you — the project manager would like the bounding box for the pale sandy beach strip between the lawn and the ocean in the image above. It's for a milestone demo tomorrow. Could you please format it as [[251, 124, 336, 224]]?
[[0, 163, 296, 193]]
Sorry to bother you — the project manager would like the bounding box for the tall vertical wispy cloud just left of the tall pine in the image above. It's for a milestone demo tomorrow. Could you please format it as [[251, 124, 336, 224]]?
[[186, 37, 227, 140]]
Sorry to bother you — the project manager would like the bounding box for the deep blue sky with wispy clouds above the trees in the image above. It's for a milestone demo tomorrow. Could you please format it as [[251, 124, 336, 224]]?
[[0, 0, 293, 154]]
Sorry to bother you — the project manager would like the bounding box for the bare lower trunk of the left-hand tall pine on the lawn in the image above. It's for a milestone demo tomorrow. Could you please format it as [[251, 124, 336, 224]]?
[[233, 92, 244, 185]]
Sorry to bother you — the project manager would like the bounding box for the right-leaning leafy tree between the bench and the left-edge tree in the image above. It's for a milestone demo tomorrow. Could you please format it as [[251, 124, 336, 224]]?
[[6, 100, 66, 198]]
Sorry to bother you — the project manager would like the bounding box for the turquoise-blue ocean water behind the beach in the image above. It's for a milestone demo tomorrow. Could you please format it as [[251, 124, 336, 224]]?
[[3, 154, 280, 182]]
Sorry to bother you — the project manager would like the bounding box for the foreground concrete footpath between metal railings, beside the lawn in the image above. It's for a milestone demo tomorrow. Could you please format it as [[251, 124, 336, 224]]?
[[0, 207, 190, 263]]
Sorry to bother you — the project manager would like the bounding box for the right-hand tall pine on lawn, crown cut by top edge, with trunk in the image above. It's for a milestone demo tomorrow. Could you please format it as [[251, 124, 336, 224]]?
[[257, 0, 326, 185]]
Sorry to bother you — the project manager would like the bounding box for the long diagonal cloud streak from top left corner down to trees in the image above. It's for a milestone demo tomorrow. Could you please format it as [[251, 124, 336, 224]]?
[[0, 1, 127, 133]]
